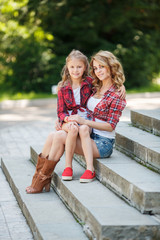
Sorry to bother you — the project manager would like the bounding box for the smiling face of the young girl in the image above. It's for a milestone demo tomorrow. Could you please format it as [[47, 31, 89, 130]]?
[[67, 58, 86, 81]]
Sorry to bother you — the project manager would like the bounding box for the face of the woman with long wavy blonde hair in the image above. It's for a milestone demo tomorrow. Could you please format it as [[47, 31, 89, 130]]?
[[93, 60, 111, 81]]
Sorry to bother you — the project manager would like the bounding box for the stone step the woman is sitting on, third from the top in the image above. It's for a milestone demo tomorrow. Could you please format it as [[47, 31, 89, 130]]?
[[74, 149, 160, 214]]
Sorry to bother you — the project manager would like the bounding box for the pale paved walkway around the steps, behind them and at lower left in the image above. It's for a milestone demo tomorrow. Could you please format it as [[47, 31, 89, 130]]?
[[0, 93, 160, 240]]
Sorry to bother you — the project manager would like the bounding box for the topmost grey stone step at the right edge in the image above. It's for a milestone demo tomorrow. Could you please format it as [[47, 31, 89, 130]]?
[[131, 109, 160, 136]]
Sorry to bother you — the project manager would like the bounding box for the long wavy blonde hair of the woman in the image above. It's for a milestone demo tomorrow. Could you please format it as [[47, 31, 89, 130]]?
[[90, 50, 125, 91]]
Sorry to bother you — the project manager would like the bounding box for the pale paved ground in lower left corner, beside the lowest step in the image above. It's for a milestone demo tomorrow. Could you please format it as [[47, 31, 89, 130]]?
[[0, 168, 33, 240]]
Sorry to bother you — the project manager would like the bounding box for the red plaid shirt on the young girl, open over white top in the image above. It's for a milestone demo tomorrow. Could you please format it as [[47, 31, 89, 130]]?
[[57, 77, 93, 123]]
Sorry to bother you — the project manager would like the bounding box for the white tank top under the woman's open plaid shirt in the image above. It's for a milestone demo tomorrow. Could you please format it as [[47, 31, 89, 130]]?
[[87, 97, 115, 138]]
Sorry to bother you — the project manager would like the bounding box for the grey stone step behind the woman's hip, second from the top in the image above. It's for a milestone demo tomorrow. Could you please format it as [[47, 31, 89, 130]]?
[[116, 122, 160, 172]]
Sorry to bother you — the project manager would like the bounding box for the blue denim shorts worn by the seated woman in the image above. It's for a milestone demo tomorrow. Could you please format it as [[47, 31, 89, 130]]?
[[91, 132, 115, 158]]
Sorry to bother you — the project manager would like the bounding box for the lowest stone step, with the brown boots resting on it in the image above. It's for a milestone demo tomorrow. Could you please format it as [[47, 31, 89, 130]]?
[[0, 155, 88, 240]]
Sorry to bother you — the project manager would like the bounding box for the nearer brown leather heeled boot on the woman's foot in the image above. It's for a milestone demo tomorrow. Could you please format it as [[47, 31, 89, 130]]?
[[27, 158, 58, 193]]
